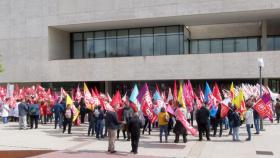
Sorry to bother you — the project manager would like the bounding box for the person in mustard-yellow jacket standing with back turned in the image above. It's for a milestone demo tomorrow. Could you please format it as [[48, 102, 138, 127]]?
[[158, 107, 169, 143]]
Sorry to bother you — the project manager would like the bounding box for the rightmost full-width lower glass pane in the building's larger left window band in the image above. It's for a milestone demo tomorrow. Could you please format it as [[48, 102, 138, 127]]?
[[166, 35, 180, 55]]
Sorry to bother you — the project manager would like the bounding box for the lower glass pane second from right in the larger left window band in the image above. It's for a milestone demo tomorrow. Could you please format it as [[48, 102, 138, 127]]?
[[154, 36, 166, 55]]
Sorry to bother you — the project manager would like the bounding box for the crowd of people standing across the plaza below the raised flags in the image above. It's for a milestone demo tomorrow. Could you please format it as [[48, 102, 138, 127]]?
[[1, 94, 280, 154]]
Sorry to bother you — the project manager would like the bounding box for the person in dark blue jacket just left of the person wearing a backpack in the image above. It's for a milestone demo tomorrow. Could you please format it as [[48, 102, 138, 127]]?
[[52, 101, 64, 129]]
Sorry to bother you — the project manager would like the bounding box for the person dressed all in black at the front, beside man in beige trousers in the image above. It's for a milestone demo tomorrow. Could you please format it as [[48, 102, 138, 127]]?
[[127, 113, 141, 154]]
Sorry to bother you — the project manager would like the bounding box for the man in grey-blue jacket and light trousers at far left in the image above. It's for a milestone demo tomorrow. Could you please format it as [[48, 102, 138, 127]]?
[[18, 100, 28, 129]]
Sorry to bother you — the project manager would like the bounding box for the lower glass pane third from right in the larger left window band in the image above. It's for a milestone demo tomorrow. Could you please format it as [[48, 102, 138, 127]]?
[[141, 36, 154, 56]]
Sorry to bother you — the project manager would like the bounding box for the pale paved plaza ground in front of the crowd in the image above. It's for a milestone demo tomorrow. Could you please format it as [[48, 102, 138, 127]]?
[[0, 122, 280, 158]]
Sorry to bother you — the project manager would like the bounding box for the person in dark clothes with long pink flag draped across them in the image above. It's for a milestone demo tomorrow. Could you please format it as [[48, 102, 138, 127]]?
[[173, 103, 188, 143]]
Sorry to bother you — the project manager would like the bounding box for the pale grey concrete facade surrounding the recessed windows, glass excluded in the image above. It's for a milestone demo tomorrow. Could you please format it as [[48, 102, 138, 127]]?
[[0, 0, 280, 83]]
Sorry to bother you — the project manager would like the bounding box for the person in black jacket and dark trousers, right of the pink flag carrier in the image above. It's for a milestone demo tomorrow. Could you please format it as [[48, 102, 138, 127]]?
[[196, 104, 210, 141]]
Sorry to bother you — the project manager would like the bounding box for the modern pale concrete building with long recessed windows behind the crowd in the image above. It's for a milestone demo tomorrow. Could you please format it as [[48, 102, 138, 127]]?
[[0, 0, 280, 92]]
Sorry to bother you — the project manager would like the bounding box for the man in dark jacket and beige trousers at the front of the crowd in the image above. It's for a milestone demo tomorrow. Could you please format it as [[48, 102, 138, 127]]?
[[105, 105, 119, 153]]
